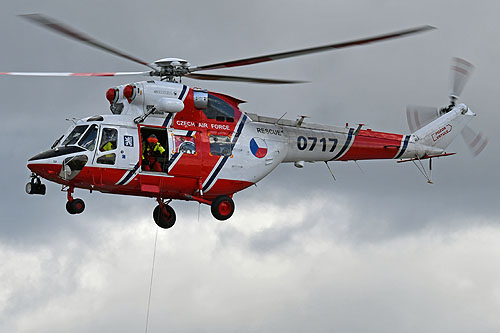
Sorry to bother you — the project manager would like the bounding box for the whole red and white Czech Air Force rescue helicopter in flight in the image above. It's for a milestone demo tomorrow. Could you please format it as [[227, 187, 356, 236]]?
[[0, 14, 486, 228]]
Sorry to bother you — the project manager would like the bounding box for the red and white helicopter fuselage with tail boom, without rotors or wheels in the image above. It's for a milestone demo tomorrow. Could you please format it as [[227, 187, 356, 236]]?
[[28, 81, 472, 224]]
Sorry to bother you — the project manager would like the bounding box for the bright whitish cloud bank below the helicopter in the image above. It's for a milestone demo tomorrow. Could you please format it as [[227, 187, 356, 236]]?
[[0, 201, 500, 332]]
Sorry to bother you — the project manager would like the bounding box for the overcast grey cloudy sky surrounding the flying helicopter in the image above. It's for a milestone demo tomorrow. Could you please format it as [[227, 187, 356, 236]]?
[[0, 0, 500, 332]]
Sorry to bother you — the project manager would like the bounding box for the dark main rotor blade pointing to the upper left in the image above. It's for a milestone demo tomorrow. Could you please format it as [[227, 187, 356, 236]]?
[[19, 14, 157, 70]]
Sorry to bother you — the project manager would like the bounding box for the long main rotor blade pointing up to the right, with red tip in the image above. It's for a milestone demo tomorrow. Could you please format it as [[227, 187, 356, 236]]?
[[190, 25, 435, 72]]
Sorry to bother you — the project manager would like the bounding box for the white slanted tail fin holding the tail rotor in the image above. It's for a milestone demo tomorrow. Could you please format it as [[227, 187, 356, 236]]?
[[413, 104, 476, 150]]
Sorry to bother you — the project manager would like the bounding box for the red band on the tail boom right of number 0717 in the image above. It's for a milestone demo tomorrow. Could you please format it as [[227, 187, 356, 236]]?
[[340, 130, 403, 161]]
